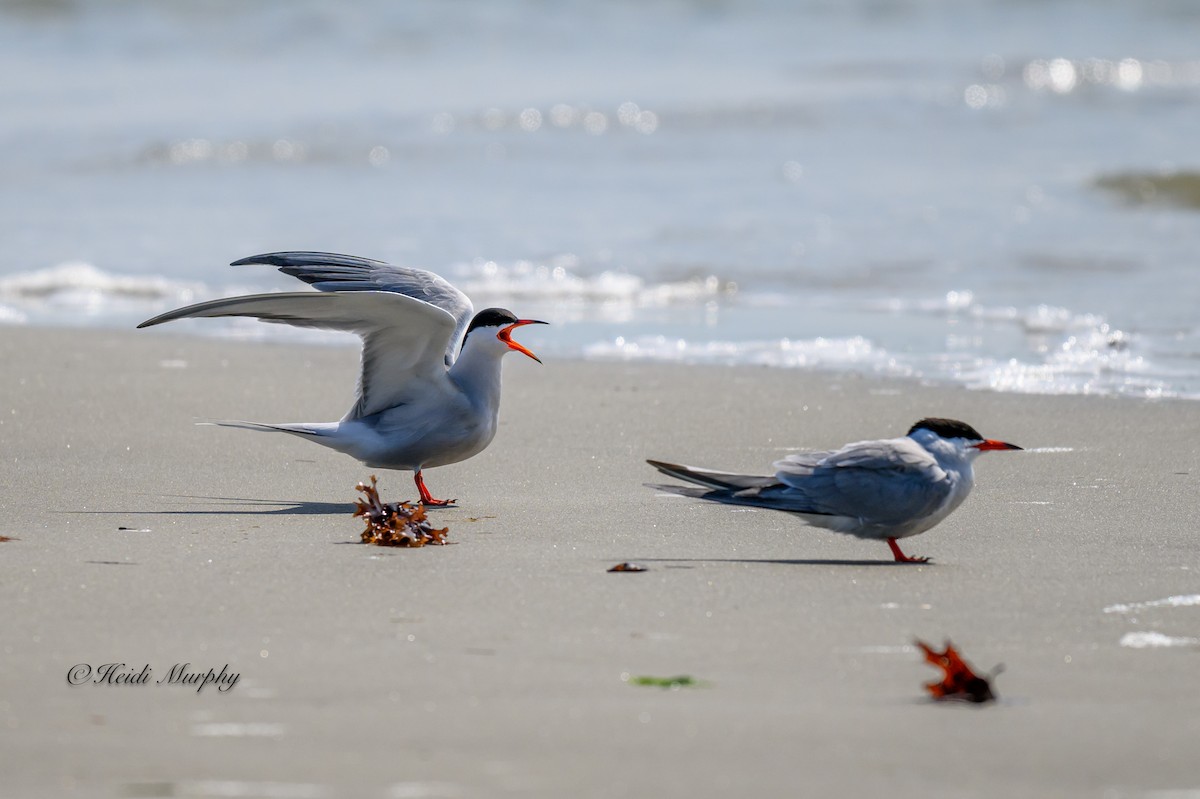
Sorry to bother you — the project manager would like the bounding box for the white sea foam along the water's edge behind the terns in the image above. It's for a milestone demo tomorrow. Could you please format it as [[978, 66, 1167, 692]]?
[[0, 261, 1192, 397]]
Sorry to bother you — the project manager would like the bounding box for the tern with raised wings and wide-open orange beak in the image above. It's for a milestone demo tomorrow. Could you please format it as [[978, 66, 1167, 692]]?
[[138, 252, 546, 505]]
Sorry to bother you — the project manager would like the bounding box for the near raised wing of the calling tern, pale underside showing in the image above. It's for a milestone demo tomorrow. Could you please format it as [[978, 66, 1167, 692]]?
[[138, 289, 456, 419]]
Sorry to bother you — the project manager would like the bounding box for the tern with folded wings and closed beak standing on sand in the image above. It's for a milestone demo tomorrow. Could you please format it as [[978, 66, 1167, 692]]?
[[647, 419, 1021, 563]]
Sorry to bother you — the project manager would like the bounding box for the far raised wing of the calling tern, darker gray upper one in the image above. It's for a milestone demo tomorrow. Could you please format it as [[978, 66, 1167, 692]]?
[[230, 252, 475, 366]]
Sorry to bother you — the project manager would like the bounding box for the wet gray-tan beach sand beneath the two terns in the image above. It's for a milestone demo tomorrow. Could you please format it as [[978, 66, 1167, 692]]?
[[0, 329, 1200, 798]]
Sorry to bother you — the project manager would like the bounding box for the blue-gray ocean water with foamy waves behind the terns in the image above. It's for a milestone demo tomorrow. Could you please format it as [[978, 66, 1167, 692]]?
[[0, 0, 1200, 398]]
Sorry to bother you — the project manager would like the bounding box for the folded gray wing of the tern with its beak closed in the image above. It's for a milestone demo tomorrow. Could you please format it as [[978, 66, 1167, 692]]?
[[770, 438, 953, 524]]
